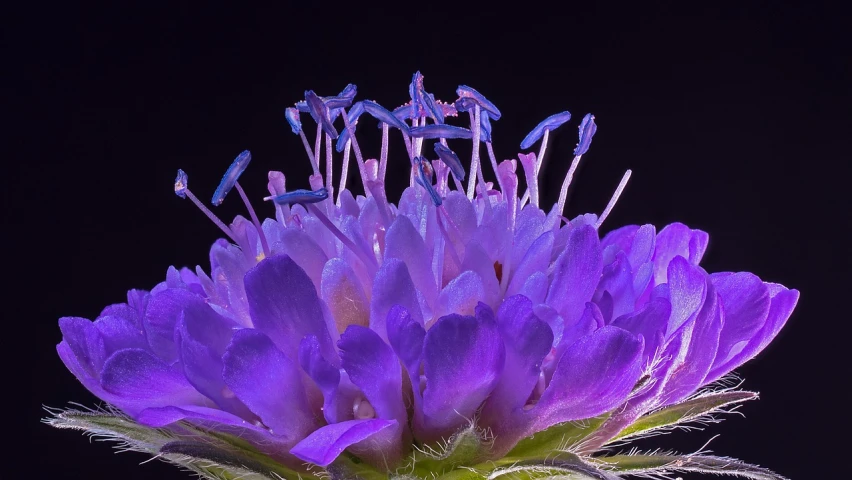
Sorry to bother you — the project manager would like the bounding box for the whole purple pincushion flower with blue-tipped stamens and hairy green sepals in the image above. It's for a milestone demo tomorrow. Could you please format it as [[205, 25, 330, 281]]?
[[48, 72, 798, 479]]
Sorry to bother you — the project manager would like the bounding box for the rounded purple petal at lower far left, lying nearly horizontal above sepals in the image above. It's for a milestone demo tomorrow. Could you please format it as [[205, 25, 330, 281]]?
[[101, 349, 209, 415]]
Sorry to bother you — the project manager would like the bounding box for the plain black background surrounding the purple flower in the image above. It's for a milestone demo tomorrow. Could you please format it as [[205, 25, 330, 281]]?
[[8, 2, 852, 479]]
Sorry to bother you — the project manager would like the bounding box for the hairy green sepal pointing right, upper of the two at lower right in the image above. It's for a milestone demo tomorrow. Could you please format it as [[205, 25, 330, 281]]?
[[609, 391, 757, 442]]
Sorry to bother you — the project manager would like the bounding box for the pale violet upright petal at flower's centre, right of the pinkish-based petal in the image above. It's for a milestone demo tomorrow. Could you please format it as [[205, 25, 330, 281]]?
[[370, 258, 423, 338]]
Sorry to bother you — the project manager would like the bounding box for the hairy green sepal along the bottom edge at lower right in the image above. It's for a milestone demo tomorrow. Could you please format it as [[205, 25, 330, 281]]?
[[595, 455, 787, 480]]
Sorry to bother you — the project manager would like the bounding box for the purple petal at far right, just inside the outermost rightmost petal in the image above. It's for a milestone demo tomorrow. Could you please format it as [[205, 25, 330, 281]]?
[[712, 272, 771, 371]]
